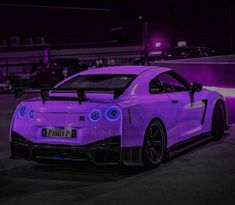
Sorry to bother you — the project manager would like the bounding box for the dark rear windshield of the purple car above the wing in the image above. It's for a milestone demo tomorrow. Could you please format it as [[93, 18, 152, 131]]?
[[58, 74, 136, 90]]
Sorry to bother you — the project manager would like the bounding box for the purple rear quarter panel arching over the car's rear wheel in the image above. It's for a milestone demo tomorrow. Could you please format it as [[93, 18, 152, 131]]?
[[118, 94, 178, 147]]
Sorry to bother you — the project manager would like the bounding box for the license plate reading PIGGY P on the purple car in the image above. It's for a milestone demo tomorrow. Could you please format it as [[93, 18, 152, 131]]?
[[42, 129, 77, 138]]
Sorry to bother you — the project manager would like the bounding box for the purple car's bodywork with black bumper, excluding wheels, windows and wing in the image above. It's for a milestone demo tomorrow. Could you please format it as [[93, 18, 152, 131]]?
[[10, 66, 228, 165]]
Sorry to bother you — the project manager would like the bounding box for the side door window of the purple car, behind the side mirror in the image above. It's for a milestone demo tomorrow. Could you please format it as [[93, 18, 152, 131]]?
[[158, 72, 189, 93]]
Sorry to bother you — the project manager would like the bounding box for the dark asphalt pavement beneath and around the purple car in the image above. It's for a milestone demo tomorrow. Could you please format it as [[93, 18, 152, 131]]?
[[0, 95, 235, 205]]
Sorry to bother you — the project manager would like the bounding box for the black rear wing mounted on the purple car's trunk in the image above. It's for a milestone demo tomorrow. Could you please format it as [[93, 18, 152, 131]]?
[[14, 88, 124, 104]]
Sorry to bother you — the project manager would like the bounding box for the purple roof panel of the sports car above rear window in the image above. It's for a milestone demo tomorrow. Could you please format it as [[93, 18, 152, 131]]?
[[79, 65, 170, 75]]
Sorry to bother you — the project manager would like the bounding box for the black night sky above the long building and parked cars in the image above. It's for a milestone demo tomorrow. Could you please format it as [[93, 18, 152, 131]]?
[[1, 0, 235, 50]]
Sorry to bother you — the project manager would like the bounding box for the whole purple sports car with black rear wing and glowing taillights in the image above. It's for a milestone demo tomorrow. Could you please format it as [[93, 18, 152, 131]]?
[[10, 66, 227, 168]]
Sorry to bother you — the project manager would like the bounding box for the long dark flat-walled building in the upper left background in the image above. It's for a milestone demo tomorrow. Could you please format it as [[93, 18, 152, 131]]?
[[0, 4, 111, 45]]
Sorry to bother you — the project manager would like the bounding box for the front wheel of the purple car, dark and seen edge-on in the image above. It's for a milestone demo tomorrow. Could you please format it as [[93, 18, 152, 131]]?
[[211, 101, 225, 140]]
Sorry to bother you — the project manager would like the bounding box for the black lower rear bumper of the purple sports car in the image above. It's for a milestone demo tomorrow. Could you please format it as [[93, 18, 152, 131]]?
[[11, 132, 142, 166]]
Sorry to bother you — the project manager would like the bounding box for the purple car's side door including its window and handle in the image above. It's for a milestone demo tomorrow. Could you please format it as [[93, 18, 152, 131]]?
[[158, 71, 206, 141]]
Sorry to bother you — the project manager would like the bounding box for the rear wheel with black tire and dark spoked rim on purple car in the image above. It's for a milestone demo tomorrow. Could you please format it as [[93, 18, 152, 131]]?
[[143, 120, 166, 169]]
